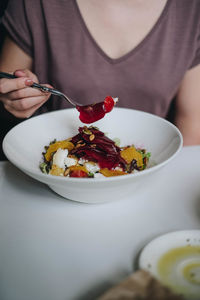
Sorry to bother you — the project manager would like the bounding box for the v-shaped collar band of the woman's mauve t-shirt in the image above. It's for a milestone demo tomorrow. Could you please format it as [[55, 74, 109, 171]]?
[[72, 0, 172, 64]]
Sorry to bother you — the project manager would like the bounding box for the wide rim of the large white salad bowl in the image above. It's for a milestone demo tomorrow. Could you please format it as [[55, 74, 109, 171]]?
[[2, 107, 183, 185]]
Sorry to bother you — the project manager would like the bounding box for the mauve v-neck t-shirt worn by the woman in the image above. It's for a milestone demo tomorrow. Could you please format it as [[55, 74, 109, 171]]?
[[2, 0, 200, 117]]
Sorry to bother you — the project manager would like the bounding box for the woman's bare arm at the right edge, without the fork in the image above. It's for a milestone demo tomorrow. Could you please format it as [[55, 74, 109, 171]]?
[[175, 65, 200, 145]]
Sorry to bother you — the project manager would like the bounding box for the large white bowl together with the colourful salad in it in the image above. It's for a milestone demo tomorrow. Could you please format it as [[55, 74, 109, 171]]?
[[3, 107, 182, 203]]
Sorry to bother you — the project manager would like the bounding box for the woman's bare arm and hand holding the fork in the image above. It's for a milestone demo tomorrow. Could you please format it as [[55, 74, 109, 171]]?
[[0, 37, 51, 118]]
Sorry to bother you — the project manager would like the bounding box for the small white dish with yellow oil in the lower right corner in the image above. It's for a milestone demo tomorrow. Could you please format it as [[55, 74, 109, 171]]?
[[139, 230, 200, 300]]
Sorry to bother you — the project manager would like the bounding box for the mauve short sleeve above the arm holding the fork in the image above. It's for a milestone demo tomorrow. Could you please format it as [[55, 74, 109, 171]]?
[[1, 0, 33, 57]]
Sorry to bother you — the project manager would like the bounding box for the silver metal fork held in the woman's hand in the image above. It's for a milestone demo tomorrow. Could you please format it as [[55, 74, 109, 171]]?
[[0, 72, 83, 106]]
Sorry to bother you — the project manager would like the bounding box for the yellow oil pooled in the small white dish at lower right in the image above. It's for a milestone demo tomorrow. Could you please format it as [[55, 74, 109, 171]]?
[[157, 245, 200, 300]]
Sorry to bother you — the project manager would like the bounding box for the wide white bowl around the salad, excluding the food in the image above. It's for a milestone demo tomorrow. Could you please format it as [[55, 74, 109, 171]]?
[[3, 108, 182, 203]]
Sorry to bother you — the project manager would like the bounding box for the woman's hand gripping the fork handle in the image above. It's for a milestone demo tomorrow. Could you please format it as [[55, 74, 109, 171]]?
[[0, 69, 51, 118]]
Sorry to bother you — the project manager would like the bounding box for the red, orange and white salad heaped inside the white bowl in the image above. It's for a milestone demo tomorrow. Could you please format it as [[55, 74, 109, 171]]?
[[40, 126, 150, 178]]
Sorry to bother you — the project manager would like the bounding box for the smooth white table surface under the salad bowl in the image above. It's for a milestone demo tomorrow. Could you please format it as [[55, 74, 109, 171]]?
[[0, 146, 200, 300]]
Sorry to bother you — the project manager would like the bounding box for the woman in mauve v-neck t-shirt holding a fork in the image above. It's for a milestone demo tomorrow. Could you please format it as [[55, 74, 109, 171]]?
[[0, 0, 200, 151]]
